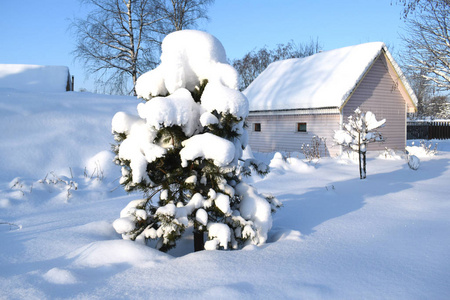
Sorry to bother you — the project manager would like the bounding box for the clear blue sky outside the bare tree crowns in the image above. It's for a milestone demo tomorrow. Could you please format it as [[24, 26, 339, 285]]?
[[0, 0, 404, 90]]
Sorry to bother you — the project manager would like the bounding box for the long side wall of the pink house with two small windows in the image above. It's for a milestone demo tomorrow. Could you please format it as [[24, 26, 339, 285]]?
[[247, 114, 340, 156]]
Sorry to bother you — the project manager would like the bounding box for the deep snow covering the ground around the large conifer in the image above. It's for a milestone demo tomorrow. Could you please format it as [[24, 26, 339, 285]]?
[[0, 89, 450, 299]]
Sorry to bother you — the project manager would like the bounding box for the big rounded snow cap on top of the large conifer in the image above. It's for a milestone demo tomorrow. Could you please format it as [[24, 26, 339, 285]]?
[[136, 30, 238, 99]]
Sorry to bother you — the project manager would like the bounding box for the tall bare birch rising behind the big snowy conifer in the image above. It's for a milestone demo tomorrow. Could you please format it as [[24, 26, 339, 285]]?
[[72, 0, 213, 94]]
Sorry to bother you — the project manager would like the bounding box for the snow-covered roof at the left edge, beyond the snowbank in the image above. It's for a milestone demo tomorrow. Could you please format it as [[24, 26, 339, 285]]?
[[0, 64, 69, 92]]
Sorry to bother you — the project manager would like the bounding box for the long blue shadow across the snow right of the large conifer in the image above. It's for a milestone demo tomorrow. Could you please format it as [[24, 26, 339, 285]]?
[[268, 159, 450, 242]]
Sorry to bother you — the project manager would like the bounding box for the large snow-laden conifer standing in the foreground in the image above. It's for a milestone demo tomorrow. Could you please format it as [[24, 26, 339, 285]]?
[[112, 30, 279, 251]]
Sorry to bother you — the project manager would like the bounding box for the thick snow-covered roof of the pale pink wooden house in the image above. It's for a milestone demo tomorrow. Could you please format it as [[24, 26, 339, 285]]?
[[244, 42, 416, 111]]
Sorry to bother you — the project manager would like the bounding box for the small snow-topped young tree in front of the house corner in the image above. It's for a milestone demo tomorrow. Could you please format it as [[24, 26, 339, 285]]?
[[334, 108, 386, 179]]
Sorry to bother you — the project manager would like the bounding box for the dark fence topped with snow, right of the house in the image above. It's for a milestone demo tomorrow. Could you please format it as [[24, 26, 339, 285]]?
[[407, 120, 450, 140]]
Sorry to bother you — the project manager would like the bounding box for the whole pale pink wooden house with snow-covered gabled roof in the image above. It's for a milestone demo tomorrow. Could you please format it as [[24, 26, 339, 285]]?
[[244, 42, 417, 156]]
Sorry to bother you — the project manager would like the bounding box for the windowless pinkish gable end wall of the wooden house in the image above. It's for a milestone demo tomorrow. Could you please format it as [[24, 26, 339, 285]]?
[[343, 55, 406, 150]]
